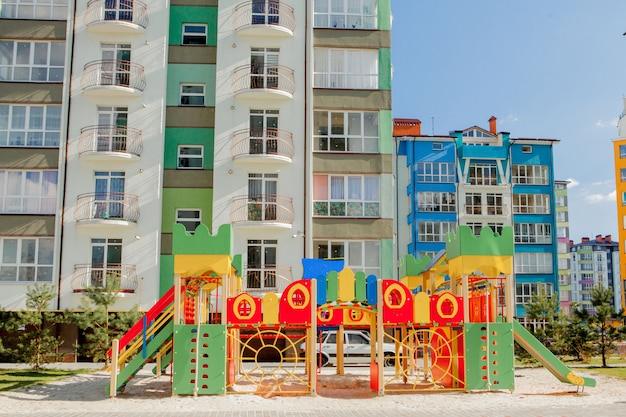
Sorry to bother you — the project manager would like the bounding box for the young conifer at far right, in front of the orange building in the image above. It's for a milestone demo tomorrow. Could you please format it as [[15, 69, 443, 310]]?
[[590, 285, 624, 368]]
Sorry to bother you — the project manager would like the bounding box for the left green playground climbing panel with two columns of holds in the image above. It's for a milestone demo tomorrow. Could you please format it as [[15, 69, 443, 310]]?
[[172, 324, 226, 395]]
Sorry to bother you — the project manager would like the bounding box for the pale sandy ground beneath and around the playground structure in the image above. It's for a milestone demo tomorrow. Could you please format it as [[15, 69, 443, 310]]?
[[0, 367, 626, 415]]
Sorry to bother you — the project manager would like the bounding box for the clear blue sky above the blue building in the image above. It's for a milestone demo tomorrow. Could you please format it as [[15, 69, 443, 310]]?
[[391, 0, 626, 243]]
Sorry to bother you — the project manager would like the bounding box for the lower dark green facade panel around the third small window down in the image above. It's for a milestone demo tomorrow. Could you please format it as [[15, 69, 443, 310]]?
[[163, 127, 215, 169]]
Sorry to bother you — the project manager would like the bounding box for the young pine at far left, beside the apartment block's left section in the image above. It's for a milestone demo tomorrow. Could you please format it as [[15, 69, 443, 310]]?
[[7, 284, 63, 369]]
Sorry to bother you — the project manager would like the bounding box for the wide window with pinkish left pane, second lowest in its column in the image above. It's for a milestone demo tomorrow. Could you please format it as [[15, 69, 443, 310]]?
[[313, 175, 380, 217]]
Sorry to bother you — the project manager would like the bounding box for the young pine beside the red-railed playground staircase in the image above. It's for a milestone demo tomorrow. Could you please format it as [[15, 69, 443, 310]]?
[[71, 274, 141, 366]]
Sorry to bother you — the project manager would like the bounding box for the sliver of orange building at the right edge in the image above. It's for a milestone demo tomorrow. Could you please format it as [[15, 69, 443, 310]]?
[[613, 98, 626, 311]]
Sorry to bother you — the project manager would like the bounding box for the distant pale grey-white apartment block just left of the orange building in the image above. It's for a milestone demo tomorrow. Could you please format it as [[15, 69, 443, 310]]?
[[570, 235, 622, 314]]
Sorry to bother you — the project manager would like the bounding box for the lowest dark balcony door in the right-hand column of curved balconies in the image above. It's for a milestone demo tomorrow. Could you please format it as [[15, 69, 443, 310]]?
[[246, 239, 278, 290]]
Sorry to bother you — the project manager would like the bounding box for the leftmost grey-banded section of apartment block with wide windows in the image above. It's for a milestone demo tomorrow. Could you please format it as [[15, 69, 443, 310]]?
[[0, 0, 71, 310]]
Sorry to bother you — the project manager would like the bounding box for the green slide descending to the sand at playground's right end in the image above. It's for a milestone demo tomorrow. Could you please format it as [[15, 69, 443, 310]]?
[[513, 320, 596, 387]]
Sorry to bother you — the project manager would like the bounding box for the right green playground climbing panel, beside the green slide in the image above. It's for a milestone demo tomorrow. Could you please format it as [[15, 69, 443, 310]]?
[[465, 323, 515, 391]]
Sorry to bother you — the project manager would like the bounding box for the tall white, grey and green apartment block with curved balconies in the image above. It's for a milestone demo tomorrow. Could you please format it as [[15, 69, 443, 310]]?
[[0, 0, 396, 324]]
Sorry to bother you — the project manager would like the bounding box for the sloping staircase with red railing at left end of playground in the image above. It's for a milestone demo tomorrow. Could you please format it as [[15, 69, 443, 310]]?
[[107, 287, 179, 392]]
